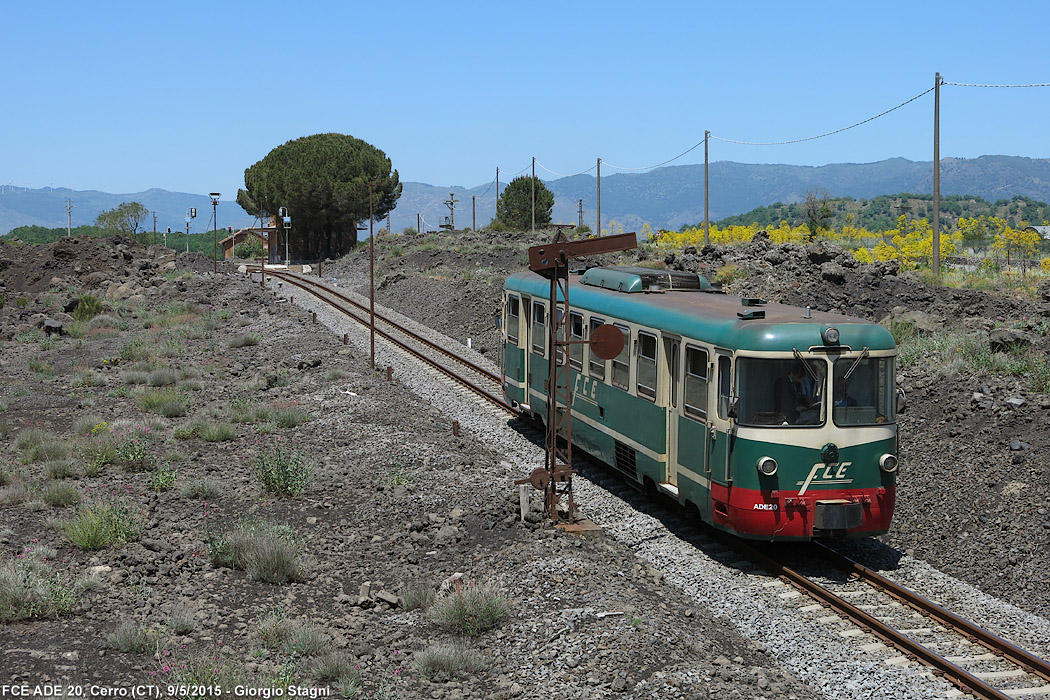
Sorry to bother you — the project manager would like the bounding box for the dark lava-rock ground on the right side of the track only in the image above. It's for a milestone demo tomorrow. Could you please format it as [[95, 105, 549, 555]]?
[[324, 228, 1050, 616]]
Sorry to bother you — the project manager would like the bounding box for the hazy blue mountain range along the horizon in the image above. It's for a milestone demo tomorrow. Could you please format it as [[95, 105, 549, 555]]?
[[0, 155, 1050, 235]]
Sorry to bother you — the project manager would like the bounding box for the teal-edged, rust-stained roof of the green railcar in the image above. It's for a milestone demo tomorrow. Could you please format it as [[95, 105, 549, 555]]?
[[506, 272, 895, 351]]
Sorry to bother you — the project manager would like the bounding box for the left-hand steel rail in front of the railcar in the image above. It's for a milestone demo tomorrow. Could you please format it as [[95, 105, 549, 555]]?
[[735, 543, 1037, 700]]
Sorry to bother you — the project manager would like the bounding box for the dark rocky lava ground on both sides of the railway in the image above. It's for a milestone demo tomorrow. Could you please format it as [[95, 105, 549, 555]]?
[[0, 228, 1050, 699]]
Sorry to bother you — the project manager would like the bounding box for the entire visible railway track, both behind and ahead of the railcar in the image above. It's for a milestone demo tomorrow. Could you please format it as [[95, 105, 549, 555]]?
[[254, 267, 1050, 700]]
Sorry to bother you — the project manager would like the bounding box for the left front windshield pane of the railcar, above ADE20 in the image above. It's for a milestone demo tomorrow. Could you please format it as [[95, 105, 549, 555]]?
[[736, 357, 827, 426]]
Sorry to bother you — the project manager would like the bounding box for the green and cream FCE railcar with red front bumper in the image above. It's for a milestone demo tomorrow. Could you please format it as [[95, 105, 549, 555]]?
[[502, 268, 897, 539]]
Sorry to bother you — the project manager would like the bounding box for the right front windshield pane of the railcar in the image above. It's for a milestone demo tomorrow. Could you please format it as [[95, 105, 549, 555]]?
[[832, 357, 897, 426]]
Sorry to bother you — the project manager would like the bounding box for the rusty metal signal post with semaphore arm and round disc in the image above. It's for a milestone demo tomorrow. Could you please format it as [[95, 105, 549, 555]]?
[[516, 231, 638, 524]]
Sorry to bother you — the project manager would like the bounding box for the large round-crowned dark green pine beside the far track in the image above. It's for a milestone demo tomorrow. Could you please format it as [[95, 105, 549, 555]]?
[[237, 133, 401, 260]]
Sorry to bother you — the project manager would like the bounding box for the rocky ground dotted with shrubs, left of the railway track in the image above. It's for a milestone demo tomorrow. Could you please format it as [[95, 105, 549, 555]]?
[[0, 239, 818, 699]]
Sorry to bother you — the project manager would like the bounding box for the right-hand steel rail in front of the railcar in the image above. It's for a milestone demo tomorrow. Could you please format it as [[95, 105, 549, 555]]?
[[814, 543, 1050, 681]]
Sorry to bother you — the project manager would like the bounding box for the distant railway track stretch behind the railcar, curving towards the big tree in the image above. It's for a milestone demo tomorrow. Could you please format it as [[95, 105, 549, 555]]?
[[249, 267, 521, 417]]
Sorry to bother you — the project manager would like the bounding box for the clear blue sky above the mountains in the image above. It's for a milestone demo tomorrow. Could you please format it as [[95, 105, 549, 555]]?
[[0, 0, 1050, 199]]
